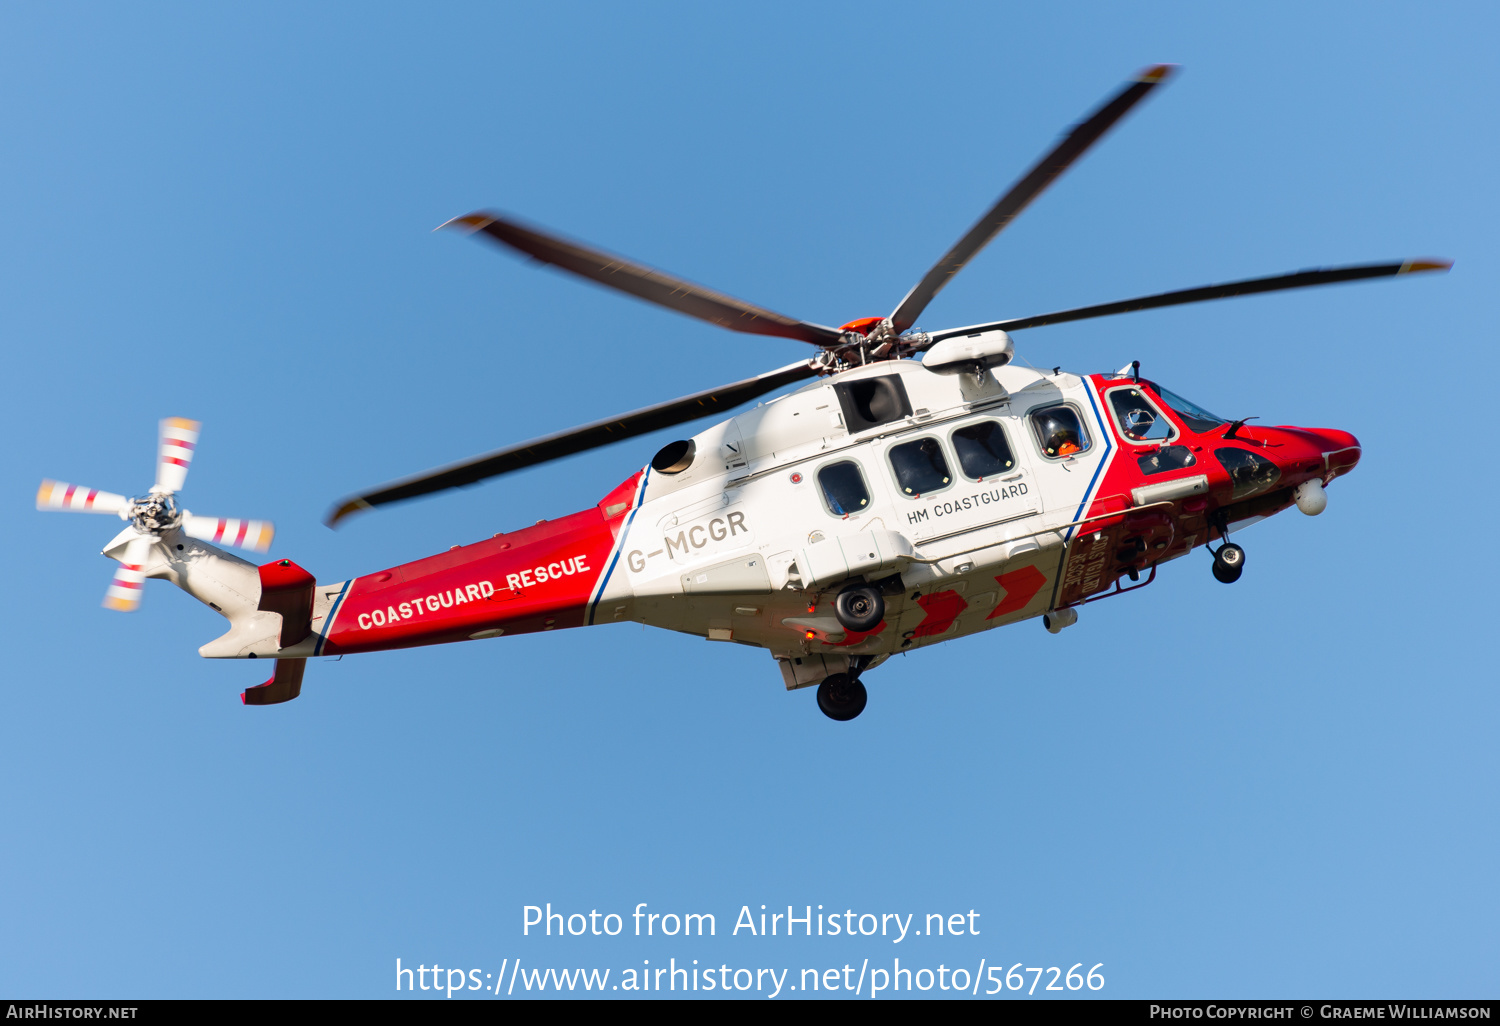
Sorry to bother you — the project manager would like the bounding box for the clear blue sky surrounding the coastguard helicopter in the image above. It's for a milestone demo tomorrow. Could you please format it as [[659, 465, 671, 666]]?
[[0, 3, 1500, 999]]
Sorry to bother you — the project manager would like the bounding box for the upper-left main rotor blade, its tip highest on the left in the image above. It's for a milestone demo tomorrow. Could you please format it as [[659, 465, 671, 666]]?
[[440, 212, 840, 345]]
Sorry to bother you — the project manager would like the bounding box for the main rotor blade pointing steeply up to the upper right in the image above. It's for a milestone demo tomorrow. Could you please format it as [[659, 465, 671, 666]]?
[[891, 65, 1176, 332]]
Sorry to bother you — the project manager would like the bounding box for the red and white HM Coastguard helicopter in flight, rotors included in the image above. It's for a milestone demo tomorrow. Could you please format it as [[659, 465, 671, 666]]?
[[38, 65, 1451, 720]]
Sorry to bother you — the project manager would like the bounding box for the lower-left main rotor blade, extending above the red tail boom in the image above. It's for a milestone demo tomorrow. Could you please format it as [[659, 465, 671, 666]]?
[[324, 362, 819, 527]]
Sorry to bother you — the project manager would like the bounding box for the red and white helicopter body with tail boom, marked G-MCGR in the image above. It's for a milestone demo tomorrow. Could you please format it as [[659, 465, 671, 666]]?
[[258, 360, 1359, 689]]
